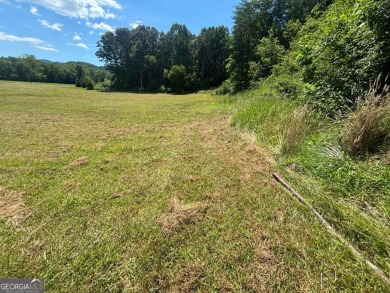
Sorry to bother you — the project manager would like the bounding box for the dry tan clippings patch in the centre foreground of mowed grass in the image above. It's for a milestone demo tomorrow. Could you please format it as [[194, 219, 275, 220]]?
[[157, 197, 208, 233]]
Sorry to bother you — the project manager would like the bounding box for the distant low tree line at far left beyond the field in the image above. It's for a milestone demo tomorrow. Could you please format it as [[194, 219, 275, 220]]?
[[0, 55, 110, 89]]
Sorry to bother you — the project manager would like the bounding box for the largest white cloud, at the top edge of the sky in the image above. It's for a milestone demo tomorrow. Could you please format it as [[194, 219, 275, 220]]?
[[21, 0, 122, 19]]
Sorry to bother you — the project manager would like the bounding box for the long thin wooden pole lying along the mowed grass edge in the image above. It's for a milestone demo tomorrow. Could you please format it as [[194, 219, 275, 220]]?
[[272, 173, 390, 286]]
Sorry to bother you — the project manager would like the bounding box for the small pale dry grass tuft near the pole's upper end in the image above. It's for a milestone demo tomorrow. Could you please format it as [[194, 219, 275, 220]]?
[[281, 106, 308, 154]]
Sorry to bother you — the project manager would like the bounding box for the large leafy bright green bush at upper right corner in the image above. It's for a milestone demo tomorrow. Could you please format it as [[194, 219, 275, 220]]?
[[295, 0, 390, 116]]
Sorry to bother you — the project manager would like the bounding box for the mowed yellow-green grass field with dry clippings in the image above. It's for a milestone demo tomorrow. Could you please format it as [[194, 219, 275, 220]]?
[[0, 82, 388, 292]]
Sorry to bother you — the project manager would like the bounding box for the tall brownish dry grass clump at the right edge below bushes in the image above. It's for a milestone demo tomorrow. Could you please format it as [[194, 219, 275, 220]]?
[[341, 82, 390, 155]]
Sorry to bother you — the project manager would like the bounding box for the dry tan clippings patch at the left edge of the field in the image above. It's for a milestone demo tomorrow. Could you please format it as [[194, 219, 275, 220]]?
[[0, 187, 31, 226]]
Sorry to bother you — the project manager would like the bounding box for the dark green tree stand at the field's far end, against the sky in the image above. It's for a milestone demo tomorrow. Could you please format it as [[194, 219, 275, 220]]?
[[96, 24, 229, 93]]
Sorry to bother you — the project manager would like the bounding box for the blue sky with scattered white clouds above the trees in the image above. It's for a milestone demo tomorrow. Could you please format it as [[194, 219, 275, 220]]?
[[0, 0, 240, 65]]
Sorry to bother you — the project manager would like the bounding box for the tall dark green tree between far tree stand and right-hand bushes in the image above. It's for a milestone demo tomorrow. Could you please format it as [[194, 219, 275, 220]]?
[[227, 0, 331, 90]]
